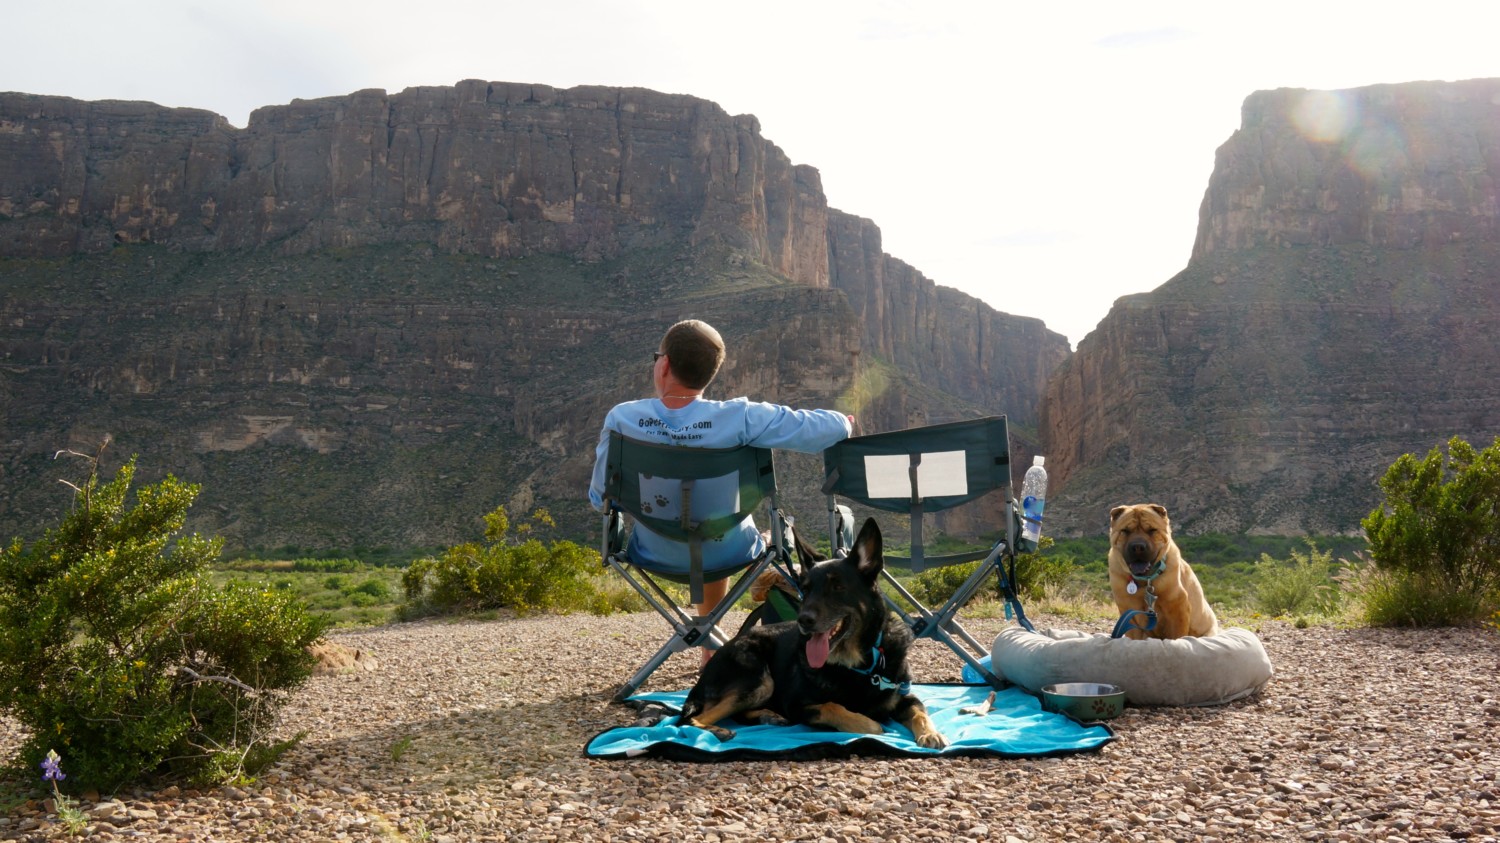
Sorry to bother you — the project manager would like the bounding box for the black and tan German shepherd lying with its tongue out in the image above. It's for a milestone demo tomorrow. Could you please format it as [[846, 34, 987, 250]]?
[[678, 518, 948, 749]]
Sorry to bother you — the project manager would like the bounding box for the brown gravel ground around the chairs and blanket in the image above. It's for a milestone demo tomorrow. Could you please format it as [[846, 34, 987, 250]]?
[[0, 615, 1500, 843]]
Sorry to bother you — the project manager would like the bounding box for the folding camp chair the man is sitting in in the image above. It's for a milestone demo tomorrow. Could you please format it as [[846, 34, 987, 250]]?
[[602, 434, 797, 701]]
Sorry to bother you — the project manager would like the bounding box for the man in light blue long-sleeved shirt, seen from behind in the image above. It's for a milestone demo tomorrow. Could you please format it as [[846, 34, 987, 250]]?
[[588, 320, 854, 662]]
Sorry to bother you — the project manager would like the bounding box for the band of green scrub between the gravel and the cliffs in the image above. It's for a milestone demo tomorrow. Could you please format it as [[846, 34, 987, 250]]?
[[215, 440, 1500, 626]]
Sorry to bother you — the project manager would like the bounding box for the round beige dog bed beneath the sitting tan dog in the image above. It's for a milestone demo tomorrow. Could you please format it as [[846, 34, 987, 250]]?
[[990, 627, 1274, 705]]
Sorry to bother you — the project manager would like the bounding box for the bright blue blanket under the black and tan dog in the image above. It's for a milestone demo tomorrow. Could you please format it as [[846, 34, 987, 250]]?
[[584, 686, 1115, 761]]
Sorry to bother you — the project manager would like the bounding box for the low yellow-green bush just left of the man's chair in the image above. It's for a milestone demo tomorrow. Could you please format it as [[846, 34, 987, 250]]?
[[401, 507, 608, 618]]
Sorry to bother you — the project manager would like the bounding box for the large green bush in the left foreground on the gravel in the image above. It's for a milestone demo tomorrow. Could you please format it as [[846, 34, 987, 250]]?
[[0, 456, 323, 791]]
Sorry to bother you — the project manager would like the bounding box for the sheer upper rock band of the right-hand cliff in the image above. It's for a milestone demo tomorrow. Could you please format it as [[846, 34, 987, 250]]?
[[1193, 80, 1500, 260]]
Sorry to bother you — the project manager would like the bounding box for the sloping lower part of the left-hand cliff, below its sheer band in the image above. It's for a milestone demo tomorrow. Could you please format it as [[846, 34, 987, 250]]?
[[0, 248, 860, 549]]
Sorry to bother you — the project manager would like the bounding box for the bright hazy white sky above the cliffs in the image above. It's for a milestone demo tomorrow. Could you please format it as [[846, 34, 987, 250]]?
[[11, 0, 1500, 344]]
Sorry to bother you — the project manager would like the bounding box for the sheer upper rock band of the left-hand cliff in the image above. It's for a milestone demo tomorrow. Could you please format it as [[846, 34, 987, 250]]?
[[0, 80, 828, 279]]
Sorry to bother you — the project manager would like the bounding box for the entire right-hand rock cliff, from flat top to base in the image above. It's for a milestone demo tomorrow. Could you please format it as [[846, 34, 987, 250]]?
[[1041, 80, 1500, 534]]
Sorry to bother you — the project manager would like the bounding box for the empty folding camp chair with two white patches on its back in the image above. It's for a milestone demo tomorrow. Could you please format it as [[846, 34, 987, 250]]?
[[824, 416, 1035, 687]]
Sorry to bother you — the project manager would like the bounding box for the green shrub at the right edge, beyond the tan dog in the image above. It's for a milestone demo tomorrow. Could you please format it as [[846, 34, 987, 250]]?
[[1352, 437, 1500, 627]]
